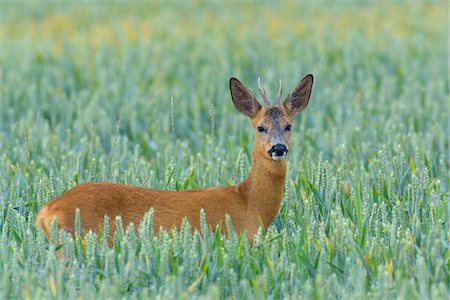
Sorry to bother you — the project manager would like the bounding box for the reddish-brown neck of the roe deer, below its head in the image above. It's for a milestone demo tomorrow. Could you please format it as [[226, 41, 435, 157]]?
[[239, 150, 287, 228]]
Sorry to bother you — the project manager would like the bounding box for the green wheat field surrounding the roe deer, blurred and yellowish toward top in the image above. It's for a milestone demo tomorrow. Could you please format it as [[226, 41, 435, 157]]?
[[0, 1, 450, 299]]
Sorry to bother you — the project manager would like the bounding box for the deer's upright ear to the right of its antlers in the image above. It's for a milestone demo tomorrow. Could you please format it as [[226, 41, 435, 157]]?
[[283, 74, 313, 115]]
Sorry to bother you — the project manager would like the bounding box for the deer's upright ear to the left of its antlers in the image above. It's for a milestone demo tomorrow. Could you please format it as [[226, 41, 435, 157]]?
[[230, 78, 261, 118]]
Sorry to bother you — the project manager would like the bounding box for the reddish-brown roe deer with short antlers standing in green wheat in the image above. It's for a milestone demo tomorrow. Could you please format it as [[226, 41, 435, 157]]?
[[37, 75, 313, 243]]
